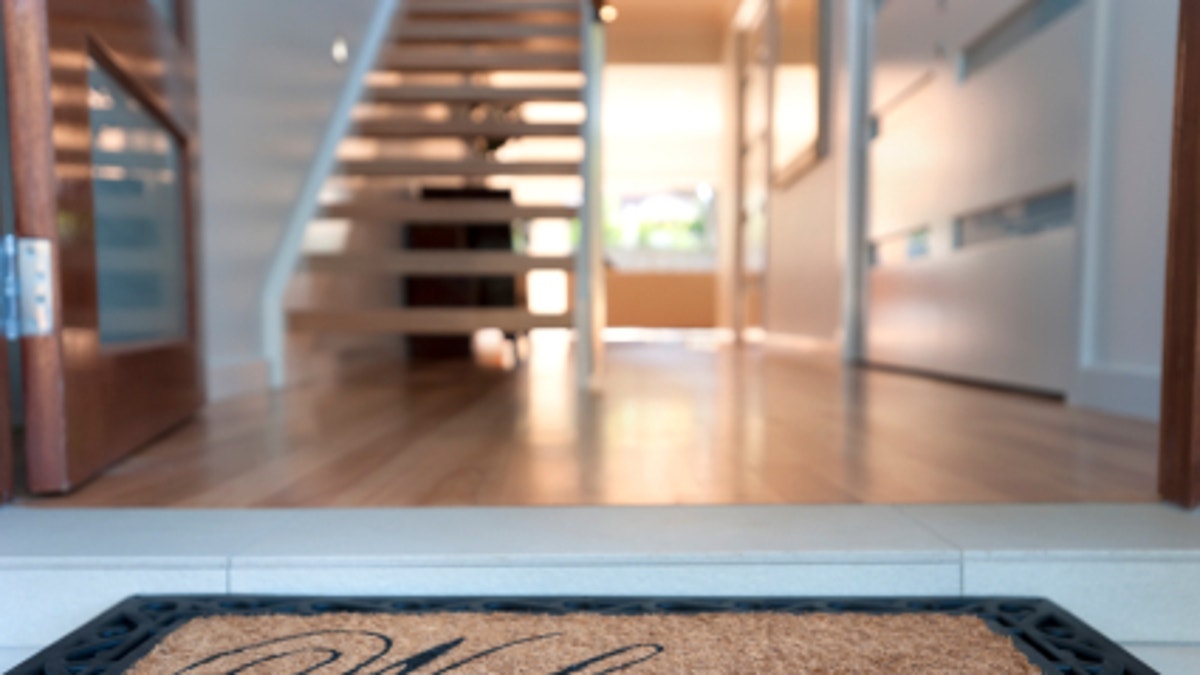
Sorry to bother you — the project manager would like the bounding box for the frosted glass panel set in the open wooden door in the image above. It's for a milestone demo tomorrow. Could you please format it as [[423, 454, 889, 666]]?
[[88, 55, 188, 345]]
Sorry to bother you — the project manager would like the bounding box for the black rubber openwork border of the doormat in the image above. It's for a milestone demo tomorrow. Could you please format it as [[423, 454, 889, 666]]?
[[10, 596, 1156, 675]]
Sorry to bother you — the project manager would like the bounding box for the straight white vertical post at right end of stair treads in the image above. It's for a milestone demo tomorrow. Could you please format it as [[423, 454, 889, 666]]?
[[575, 0, 607, 390]]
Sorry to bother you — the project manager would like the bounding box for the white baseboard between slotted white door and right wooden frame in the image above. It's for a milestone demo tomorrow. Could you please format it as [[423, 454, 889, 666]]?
[[1067, 366, 1162, 422]]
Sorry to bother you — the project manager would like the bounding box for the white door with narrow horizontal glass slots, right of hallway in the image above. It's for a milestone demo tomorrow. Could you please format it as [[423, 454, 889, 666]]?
[[866, 0, 1092, 393]]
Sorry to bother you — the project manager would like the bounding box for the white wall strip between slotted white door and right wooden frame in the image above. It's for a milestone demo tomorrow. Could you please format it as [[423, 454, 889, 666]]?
[[1070, 0, 1178, 418]]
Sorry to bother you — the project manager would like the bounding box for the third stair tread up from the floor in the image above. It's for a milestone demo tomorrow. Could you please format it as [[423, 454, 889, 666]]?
[[323, 198, 578, 225]]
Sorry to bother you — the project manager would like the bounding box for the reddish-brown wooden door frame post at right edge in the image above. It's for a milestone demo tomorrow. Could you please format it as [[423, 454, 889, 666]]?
[[1158, 0, 1200, 508]]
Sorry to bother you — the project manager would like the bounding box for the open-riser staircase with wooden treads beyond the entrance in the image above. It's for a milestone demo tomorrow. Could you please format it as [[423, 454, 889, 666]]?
[[289, 0, 594, 344]]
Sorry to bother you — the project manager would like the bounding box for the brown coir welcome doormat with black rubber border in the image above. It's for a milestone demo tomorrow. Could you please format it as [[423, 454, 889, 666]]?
[[13, 596, 1153, 675]]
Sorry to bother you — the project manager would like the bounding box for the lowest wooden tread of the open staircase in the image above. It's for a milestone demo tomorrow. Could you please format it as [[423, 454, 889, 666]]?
[[288, 307, 574, 335]]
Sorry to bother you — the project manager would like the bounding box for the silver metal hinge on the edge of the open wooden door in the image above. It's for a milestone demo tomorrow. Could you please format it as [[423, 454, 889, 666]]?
[[2, 234, 55, 340]]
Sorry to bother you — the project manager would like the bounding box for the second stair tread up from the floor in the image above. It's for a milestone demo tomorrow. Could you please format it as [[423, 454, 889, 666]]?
[[306, 251, 575, 276]]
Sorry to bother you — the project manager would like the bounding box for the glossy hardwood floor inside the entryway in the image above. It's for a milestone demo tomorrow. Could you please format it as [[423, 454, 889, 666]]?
[[25, 342, 1157, 507]]
